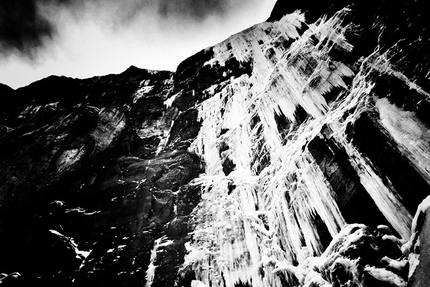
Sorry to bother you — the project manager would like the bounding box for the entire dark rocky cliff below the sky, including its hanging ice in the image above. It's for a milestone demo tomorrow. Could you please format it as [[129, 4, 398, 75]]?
[[0, 0, 430, 287]]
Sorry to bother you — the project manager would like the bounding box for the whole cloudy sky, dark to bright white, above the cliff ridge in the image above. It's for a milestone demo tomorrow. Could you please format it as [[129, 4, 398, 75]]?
[[0, 0, 276, 88]]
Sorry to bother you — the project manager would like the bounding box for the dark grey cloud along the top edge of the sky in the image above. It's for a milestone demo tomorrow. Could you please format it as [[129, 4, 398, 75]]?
[[0, 0, 256, 60]]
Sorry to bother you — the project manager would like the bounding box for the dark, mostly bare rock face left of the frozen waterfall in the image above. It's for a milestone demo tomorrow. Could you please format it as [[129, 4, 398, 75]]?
[[0, 67, 201, 286]]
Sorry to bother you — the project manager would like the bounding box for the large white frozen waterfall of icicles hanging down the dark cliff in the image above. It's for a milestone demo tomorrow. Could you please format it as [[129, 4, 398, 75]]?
[[182, 9, 430, 287]]
